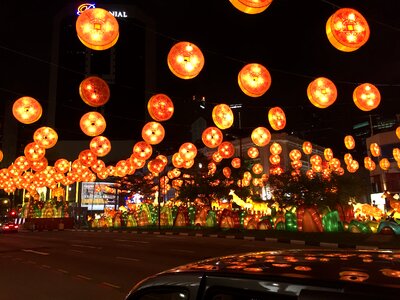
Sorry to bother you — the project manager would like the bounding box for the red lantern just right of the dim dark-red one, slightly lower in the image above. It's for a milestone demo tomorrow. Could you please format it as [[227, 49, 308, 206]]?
[[147, 94, 174, 122]]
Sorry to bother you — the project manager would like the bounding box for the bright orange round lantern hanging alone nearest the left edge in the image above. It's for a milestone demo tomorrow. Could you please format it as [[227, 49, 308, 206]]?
[[12, 96, 42, 124]]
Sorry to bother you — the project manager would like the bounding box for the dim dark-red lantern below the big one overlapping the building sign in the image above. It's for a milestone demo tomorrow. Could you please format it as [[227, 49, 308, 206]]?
[[79, 76, 110, 107]]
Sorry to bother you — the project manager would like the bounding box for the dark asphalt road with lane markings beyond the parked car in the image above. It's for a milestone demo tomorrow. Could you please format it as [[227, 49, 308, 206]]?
[[0, 231, 310, 300]]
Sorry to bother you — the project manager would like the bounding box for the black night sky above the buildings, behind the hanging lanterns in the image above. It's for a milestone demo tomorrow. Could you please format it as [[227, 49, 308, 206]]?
[[0, 0, 400, 162]]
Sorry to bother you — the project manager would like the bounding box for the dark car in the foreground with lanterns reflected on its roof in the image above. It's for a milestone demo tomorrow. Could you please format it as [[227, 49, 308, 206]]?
[[126, 249, 400, 300]]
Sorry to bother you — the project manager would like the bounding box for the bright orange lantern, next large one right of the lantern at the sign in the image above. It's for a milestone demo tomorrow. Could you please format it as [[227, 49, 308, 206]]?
[[167, 42, 204, 79]]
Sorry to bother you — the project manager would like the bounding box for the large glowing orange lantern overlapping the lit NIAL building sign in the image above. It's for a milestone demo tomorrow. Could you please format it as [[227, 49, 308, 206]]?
[[76, 8, 119, 50]]
